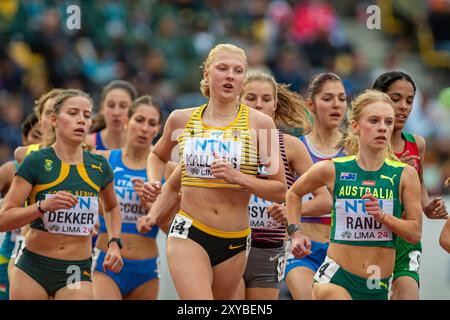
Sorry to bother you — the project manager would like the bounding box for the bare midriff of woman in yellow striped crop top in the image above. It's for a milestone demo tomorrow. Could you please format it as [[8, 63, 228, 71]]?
[[180, 187, 251, 231]]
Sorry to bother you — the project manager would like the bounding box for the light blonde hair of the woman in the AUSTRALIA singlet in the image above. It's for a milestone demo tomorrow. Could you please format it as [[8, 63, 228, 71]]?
[[340, 90, 398, 161]]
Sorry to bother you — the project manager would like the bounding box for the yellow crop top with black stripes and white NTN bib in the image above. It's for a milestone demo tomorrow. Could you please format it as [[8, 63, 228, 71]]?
[[178, 104, 259, 190]]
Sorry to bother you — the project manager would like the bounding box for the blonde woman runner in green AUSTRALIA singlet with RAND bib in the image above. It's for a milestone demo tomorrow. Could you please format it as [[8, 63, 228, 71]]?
[[286, 90, 422, 300]]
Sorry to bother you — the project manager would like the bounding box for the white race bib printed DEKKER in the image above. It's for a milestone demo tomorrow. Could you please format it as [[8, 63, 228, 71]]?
[[43, 194, 98, 236]]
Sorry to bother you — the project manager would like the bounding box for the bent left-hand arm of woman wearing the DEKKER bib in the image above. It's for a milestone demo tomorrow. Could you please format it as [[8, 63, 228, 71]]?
[[0, 176, 78, 232]]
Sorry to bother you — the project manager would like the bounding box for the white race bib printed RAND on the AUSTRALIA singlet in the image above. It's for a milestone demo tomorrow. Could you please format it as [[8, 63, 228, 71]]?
[[334, 199, 394, 241]]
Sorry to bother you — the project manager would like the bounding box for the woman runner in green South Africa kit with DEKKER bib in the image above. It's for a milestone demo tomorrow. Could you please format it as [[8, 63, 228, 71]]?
[[0, 90, 123, 300]]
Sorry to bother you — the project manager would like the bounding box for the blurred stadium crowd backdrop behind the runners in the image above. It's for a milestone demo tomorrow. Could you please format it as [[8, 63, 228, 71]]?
[[0, 0, 450, 299]]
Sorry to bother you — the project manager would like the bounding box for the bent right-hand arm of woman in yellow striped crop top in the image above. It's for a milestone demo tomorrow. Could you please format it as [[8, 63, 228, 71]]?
[[221, 109, 286, 203]]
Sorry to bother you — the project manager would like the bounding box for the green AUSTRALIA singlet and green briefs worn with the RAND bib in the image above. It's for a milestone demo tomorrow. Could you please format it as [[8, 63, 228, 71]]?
[[314, 156, 406, 300]]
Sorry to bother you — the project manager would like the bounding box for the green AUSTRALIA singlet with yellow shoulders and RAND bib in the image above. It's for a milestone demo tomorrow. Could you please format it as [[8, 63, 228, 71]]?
[[330, 156, 406, 244]]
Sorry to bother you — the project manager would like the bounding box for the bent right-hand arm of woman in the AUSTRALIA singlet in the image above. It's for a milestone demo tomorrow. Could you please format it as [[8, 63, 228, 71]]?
[[381, 165, 422, 244]]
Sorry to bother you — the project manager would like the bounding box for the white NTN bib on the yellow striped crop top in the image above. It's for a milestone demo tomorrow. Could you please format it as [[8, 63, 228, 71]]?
[[183, 135, 242, 179]]
